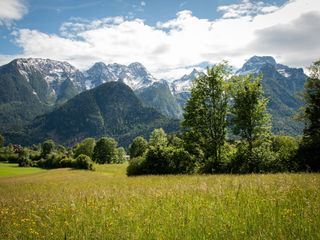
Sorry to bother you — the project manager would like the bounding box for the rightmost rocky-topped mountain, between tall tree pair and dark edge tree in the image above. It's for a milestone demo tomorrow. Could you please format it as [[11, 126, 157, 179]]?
[[237, 56, 307, 135]]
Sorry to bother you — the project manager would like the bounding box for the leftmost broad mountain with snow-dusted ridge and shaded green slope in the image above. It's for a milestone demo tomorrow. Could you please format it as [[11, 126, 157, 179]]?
[[0, 58, 84, 132]]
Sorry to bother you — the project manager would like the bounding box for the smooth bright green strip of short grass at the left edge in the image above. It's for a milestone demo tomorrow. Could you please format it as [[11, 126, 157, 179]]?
[[0, 162, 46, 177]]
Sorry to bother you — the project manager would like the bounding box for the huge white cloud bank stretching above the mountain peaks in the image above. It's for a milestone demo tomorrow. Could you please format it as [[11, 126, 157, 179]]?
[[2, 0, 320, 79]]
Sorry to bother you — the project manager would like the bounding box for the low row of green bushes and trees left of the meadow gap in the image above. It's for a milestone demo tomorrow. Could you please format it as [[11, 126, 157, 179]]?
[[0, 135, 126, 170]]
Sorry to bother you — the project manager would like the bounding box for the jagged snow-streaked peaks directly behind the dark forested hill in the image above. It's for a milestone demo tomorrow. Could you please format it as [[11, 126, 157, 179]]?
[[85, 62, 182, 118]]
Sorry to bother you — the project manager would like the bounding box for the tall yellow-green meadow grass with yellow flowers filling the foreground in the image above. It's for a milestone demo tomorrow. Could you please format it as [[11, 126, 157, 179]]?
[[0, 165, 320, 239]]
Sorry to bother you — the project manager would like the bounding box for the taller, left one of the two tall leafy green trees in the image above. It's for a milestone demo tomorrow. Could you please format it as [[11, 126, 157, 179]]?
[[182, 62, 231, 172]]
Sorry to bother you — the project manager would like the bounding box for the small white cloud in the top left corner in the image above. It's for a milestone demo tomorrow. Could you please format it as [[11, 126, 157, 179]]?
[[0, 0, 27, 25]]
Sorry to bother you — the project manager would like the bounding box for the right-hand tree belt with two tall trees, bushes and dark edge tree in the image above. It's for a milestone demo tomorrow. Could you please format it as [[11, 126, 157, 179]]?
[[127, 61, 320, 175]]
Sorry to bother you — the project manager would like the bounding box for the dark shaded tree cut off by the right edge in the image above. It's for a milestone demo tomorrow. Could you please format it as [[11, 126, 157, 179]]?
[[299, 59, 320, 171]]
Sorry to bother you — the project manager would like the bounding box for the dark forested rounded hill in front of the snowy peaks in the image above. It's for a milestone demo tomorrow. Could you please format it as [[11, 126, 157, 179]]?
[[15, 82, 179, 145]]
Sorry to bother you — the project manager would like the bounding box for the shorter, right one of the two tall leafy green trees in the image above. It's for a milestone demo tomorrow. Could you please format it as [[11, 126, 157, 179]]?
[[231, 75, 271, 155]]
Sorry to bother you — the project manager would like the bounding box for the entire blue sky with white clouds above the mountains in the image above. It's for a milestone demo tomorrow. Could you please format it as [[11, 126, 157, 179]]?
[[0, 0, 320, 80]]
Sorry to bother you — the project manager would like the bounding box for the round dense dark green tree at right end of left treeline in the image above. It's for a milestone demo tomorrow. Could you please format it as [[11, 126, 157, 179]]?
[[93, 137, 118, 164]]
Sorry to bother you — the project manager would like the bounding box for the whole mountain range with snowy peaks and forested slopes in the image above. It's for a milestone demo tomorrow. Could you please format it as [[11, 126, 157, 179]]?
[[0, 56, 306, 144]]
